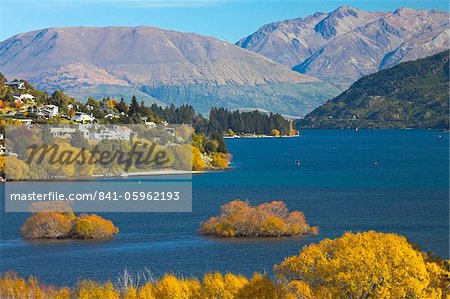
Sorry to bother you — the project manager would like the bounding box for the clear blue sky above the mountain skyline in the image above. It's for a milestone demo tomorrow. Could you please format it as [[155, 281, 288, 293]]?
[[0, 0, 449, 42]]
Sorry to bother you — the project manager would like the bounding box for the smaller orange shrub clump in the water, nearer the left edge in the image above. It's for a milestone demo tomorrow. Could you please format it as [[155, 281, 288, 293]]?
[[20, 206, 119, 239]]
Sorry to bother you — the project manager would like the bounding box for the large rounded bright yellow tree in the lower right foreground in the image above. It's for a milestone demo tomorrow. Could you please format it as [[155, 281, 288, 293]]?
[[275, 231, 450, 298]]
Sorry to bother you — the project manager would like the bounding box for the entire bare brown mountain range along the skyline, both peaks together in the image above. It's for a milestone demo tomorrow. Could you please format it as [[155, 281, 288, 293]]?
[[0, 6, 449, 117]]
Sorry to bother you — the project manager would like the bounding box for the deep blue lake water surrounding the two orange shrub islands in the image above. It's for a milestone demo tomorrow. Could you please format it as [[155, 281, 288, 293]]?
[[0, 130, 449, 285]]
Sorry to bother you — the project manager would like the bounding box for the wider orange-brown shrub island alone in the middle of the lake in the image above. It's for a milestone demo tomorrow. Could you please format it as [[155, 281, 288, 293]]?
[[199, 200, 319, 238]]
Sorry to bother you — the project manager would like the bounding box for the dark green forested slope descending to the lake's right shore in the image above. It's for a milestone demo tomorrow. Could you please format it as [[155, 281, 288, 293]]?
[[301, 50, 450, 129]]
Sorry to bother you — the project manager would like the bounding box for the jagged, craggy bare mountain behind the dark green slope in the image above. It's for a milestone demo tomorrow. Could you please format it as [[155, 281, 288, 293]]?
[[237, 6, 450, 88]]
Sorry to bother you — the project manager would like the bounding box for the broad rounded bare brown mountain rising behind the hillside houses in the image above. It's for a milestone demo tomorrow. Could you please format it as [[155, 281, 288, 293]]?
[[0, 26, 338, 115]]
